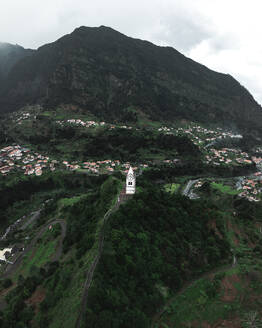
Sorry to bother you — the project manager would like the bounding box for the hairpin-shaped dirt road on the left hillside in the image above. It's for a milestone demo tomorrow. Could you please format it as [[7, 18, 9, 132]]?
[[1, 219, 66, 279]]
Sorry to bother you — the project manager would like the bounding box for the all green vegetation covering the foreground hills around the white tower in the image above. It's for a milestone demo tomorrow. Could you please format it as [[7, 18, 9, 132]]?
[[0, 155, 262, 328]]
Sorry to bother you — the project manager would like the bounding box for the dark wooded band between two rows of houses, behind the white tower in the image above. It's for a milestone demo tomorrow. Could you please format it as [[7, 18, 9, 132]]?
[[77, 129, 200, 160]]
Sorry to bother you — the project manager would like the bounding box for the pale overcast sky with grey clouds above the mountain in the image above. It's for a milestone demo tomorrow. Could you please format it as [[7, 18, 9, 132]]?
[[0, 0, 262, 104]]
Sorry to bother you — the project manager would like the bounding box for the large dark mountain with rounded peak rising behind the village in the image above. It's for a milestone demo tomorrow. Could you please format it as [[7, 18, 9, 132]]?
[[0, 26, 262, 131]]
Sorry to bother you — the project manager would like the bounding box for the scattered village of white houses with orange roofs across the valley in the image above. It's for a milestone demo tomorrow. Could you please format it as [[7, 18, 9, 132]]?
[[0, 111, 262, 205]]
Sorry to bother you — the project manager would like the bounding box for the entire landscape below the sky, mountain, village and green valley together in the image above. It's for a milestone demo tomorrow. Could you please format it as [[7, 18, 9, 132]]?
[[0, 26, 262, 328]]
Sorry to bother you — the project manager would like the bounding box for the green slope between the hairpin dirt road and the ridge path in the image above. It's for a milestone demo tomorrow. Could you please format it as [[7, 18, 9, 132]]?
[[1, 176, 122, 328]]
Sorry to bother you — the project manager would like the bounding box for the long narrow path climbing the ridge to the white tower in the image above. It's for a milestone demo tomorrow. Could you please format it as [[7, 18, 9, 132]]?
[[75, 189, 127, 328]]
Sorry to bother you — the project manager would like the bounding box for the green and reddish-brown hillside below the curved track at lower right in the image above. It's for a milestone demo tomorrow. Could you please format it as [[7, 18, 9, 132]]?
[[160, 267, 262, 328]]
